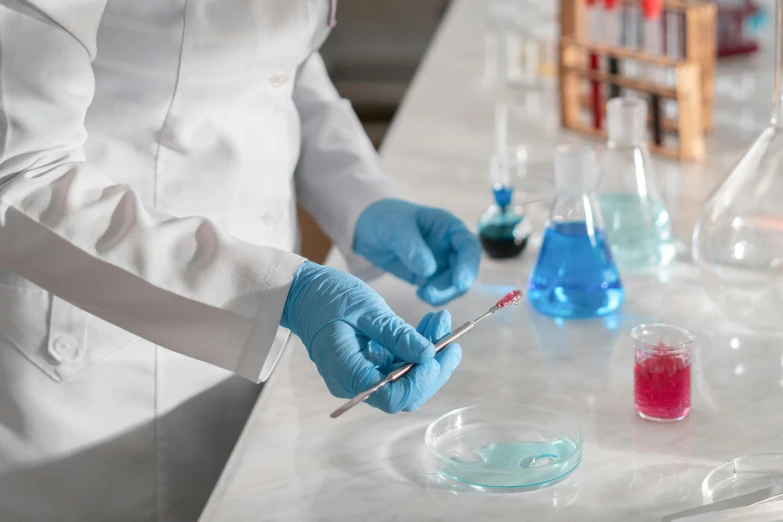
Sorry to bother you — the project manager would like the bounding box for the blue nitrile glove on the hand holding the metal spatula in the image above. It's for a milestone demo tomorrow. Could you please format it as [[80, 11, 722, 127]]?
[[280, 261, 462, 413]]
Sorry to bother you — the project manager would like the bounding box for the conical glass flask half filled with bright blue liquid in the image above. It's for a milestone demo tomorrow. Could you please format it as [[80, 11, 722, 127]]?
[[528, 145, 624, 318]]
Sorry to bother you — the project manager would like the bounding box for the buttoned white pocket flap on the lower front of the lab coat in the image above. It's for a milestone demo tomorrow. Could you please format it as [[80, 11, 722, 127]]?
[[0, 283, 135, 382]]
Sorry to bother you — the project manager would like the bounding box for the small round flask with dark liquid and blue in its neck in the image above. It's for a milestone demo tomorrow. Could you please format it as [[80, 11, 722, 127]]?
[[478, 154, 532, 259]]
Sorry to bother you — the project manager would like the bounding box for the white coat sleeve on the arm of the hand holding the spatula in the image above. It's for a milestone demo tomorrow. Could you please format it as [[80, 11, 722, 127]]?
[[0, 0, 301, 380]]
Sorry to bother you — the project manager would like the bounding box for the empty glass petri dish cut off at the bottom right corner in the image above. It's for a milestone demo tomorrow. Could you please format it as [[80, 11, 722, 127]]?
[[701, 453, 783, 504]]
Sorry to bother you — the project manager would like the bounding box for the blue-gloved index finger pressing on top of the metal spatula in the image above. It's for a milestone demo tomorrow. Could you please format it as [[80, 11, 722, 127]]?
[[356, 303, 435, 363]]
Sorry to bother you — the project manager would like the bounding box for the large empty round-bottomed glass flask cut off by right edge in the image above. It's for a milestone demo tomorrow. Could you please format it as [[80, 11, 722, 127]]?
[[693, 0, 783, 331]]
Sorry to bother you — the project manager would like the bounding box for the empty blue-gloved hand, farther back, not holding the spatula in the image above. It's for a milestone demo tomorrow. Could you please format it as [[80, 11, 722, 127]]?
[[353, 199, 481, 306]]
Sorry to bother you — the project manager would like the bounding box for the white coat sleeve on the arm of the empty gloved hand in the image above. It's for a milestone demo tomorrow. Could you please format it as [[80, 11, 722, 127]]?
[[294, 53, 395, 279]]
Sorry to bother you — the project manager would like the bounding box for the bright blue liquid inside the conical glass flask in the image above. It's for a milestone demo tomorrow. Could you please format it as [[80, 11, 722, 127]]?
[[528, 221, 625, 319]]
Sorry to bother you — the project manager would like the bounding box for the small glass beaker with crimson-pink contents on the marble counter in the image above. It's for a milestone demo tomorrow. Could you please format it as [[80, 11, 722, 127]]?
[[631, 324, 695, 421]]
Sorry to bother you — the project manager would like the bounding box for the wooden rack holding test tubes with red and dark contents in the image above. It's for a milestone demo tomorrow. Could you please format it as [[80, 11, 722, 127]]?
[[559, 0, 717, 160]]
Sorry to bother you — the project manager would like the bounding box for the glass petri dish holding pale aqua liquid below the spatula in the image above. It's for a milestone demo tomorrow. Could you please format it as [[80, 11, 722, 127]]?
[[424, 403, 584, 490]]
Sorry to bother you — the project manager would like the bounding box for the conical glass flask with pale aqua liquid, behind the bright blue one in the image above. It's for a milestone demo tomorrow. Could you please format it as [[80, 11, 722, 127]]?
[[598, 97, 677, 273]]
